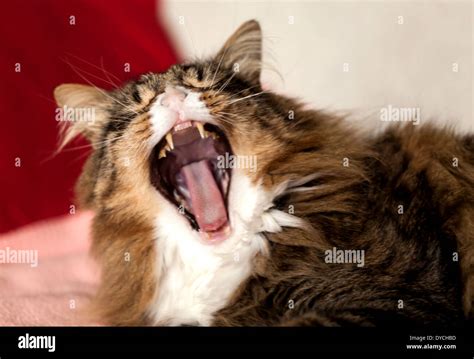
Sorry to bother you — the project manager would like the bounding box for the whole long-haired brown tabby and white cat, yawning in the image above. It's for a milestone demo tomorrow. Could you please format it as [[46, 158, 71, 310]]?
[[54, 20, 474, 326]]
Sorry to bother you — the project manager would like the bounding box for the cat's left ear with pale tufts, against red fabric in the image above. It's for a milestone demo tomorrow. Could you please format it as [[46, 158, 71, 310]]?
[[54, 84, 107, 149]]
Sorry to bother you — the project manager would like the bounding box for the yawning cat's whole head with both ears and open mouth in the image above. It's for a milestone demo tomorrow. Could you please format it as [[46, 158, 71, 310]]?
[[55, 21, 314, 248]]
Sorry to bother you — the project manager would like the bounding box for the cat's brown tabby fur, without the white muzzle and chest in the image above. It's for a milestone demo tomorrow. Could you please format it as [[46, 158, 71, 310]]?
[[55, 21, 474, 326]]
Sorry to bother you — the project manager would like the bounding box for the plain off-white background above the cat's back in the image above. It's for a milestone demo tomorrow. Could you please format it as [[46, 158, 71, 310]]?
[[161, 0, 474, 131]]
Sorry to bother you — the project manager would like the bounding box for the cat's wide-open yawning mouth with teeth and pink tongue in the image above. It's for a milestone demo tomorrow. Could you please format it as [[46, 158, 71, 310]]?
[[150, 121, 231, 242]]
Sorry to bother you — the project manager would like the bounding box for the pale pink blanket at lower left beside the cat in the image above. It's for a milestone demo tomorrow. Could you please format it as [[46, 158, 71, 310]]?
[[0, 212, 99, 326]]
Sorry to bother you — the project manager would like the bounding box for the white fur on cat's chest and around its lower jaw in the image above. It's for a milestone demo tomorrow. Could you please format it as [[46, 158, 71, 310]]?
[[149, 170, 301, 325]]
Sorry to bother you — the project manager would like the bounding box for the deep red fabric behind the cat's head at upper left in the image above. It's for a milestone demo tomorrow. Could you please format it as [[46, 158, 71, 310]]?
[[0, 0, 176, 232]]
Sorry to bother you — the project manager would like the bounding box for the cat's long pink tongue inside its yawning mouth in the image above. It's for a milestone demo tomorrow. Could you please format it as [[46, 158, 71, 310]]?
[[181, 160, 227, 232]]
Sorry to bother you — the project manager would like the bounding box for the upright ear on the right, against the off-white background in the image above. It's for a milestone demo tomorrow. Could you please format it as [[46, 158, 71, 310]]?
[[215, 20, 262, 83]]
